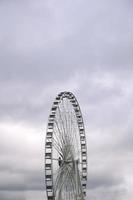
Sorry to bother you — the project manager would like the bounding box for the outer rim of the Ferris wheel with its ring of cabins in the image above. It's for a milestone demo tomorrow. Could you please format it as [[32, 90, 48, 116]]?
[[45, 92, 87, 200]]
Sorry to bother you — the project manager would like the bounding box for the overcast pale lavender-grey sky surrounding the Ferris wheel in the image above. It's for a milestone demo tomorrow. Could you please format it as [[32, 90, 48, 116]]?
[[0, 0, 133, 200]]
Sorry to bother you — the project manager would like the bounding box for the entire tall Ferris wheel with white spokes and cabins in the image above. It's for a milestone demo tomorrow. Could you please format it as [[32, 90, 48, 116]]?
[[45, 92, 87, 200]]
